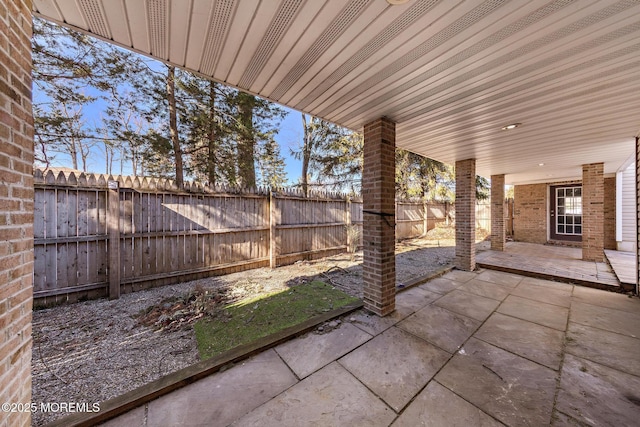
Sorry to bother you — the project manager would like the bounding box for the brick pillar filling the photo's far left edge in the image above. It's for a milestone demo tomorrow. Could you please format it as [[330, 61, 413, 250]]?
[[0, 0, 33, 426]]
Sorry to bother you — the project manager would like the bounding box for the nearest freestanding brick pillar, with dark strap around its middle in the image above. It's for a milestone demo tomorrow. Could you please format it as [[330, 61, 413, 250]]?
[[362, 118, 396, 316]]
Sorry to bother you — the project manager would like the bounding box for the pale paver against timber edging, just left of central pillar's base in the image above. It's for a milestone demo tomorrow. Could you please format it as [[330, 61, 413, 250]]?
[[276, 323, 371, 378]]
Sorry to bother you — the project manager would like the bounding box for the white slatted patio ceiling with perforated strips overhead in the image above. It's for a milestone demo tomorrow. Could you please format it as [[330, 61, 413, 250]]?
[[33, 0, 640, 183]]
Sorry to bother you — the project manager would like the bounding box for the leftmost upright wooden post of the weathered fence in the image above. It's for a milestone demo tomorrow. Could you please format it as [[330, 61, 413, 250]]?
[[107, 181, 120, 299]]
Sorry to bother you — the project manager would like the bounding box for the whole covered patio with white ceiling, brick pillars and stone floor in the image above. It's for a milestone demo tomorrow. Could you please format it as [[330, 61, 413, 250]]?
[[0, 0, 640, 425]]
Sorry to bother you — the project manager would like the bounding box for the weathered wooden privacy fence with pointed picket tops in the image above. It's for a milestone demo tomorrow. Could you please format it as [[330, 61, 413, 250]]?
[[34, 171, 480, 305]]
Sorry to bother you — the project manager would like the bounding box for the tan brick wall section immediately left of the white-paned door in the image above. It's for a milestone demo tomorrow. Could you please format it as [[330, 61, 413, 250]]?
[[513, 184, 548, 243]]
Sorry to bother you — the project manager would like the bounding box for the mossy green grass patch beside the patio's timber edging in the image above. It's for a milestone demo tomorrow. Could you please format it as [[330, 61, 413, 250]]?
[[194, 281, 358, 360]]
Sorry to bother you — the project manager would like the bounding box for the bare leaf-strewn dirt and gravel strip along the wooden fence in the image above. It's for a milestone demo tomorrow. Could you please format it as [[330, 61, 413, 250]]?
[[32, 239, 490, 425]]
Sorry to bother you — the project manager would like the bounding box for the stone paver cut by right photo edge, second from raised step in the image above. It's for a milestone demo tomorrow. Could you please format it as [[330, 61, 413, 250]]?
[[571, 301, 640, 338]]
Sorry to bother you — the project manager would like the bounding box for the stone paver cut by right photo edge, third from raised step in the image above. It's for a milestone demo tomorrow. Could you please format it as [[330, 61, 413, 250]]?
[[565, 322, 640, 376]]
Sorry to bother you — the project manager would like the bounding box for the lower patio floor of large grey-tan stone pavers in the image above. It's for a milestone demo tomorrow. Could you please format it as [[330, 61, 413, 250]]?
[[101, 270, 640, 427]]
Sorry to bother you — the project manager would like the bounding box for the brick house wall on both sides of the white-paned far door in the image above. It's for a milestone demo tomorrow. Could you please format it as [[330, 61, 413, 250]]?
[[513, 180, 616, 249]]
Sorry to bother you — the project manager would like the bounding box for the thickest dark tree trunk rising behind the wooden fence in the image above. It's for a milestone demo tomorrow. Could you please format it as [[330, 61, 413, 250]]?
[[237, 92, 256, 188]]
